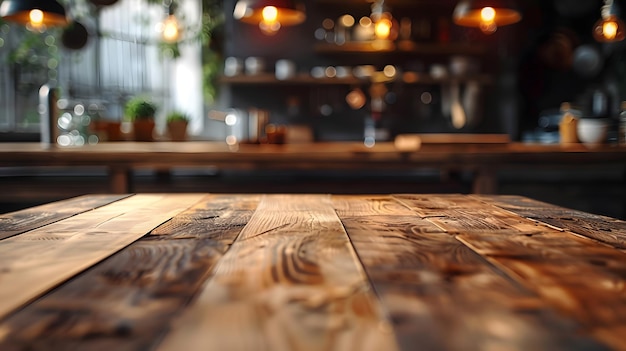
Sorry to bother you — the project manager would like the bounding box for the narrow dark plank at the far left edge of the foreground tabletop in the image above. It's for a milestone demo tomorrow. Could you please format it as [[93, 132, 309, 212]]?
[[0, 195, 129, 240]]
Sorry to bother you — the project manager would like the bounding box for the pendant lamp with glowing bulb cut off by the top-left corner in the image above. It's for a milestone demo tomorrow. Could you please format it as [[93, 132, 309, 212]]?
[[0, 0, 68, 27]]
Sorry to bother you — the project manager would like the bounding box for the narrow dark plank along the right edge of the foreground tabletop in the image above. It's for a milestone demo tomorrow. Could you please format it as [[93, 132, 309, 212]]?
[[476, 196, 626, 250]]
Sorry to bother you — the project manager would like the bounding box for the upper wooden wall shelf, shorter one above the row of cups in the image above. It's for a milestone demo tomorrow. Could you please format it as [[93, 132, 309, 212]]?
[[315, 41, 487, 55]]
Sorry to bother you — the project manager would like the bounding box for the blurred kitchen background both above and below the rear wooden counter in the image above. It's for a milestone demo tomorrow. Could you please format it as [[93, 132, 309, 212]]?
[[0, 0, 626, 217]]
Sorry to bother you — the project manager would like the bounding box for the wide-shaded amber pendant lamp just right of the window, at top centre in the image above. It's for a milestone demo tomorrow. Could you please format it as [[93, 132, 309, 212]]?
[[233, 0, 306, 35]]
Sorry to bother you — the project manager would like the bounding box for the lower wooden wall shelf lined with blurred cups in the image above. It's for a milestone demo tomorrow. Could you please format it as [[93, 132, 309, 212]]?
[[220, 72, 493, 85]]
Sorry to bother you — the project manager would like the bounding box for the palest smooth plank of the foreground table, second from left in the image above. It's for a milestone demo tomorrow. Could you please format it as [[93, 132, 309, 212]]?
[[0, 194, 202, 319]]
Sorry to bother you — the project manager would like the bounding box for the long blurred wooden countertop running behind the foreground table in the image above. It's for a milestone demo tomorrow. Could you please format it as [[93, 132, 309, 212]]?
[[0, 141, 626, 169]]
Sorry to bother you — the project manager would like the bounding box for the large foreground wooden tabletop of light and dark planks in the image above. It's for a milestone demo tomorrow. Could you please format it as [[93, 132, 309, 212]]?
[[0, 194, 626, 351]]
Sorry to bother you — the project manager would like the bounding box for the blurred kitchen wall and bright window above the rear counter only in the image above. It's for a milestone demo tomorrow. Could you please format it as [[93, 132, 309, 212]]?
[[0, 0, 626, 142]]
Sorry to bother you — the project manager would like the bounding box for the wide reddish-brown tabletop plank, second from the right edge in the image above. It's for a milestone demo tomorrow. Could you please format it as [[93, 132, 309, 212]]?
[[403, 196, 626, 349]]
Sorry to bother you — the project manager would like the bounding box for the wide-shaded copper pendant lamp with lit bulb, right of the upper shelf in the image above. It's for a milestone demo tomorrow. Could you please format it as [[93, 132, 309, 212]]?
[[452, 0, 522, 34]]
